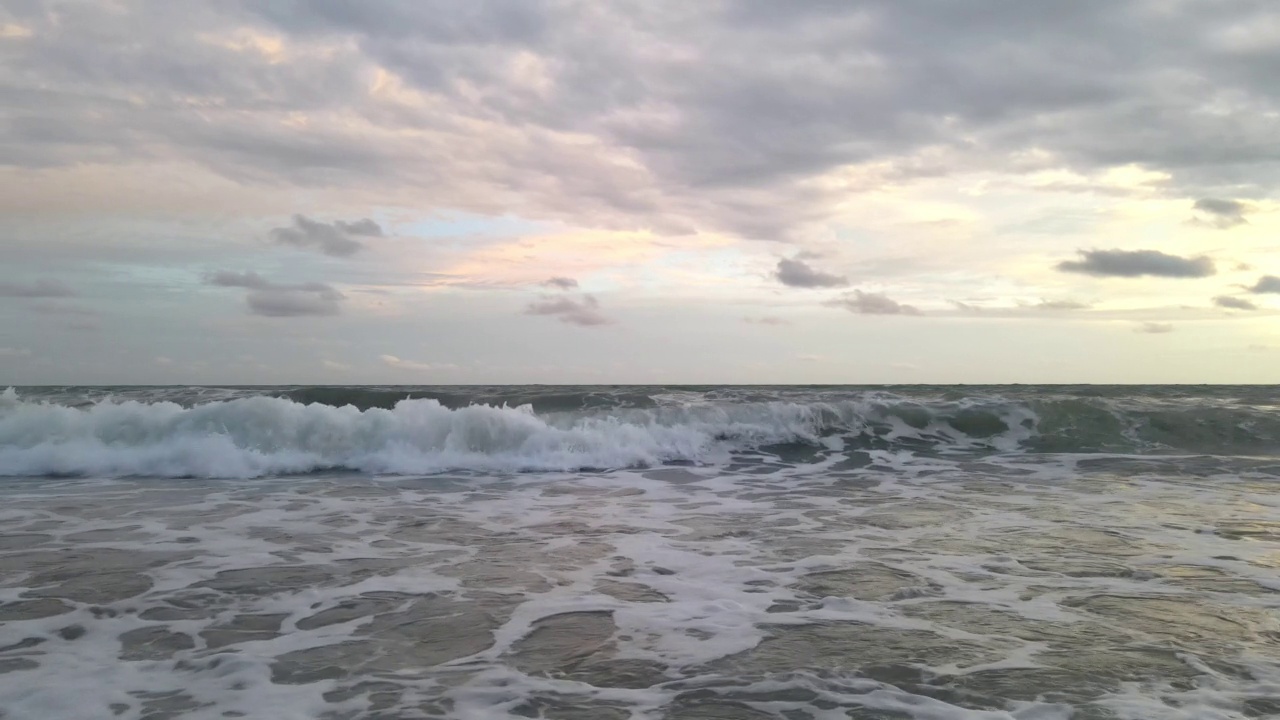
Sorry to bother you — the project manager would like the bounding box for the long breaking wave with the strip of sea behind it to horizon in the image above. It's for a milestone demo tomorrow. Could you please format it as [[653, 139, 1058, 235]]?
[[0, 387, 1280, 478]]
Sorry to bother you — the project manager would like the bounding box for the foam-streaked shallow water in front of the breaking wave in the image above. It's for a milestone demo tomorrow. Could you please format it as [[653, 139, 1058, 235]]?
[[0, 389, 1280, 720]]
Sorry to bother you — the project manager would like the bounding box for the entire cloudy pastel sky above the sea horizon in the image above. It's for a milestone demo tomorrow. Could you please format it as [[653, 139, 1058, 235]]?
[[0, 0, 1280, 386]]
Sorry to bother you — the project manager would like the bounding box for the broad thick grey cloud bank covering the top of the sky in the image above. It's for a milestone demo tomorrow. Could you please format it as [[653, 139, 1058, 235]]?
[[10, 0, 1280, 240]]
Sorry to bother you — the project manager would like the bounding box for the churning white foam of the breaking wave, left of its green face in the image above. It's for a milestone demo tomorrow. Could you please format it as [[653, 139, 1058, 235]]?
[[0, 389, 849, 478]]
